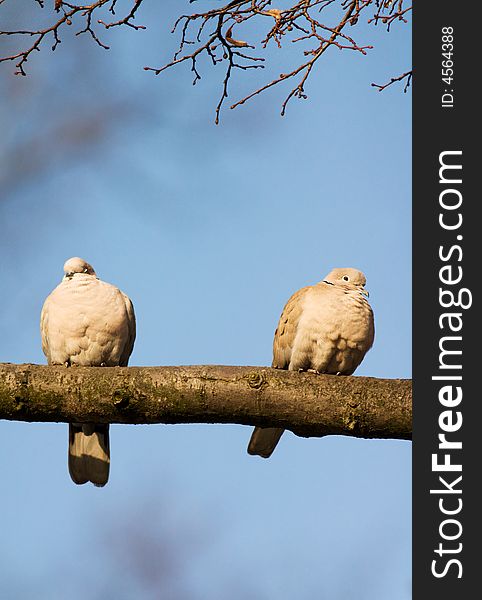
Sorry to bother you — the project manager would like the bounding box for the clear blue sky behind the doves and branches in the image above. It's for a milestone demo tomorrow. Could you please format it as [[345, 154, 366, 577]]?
[[0, 2, 411, 600]]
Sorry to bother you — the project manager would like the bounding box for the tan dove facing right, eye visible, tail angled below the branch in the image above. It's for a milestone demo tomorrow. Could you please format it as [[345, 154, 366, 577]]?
[[248, 268, 375, 458]]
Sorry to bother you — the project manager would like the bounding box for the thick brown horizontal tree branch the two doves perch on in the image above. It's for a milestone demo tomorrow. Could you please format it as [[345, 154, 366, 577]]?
[[0, 364, 412, 439]]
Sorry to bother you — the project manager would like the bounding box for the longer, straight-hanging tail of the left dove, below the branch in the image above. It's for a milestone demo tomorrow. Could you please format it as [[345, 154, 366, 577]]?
[[69, 423, 110, 487]]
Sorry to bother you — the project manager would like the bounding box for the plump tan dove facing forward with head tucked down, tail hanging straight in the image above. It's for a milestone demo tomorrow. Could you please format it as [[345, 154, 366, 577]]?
[[40, 257, 136, 486]]
